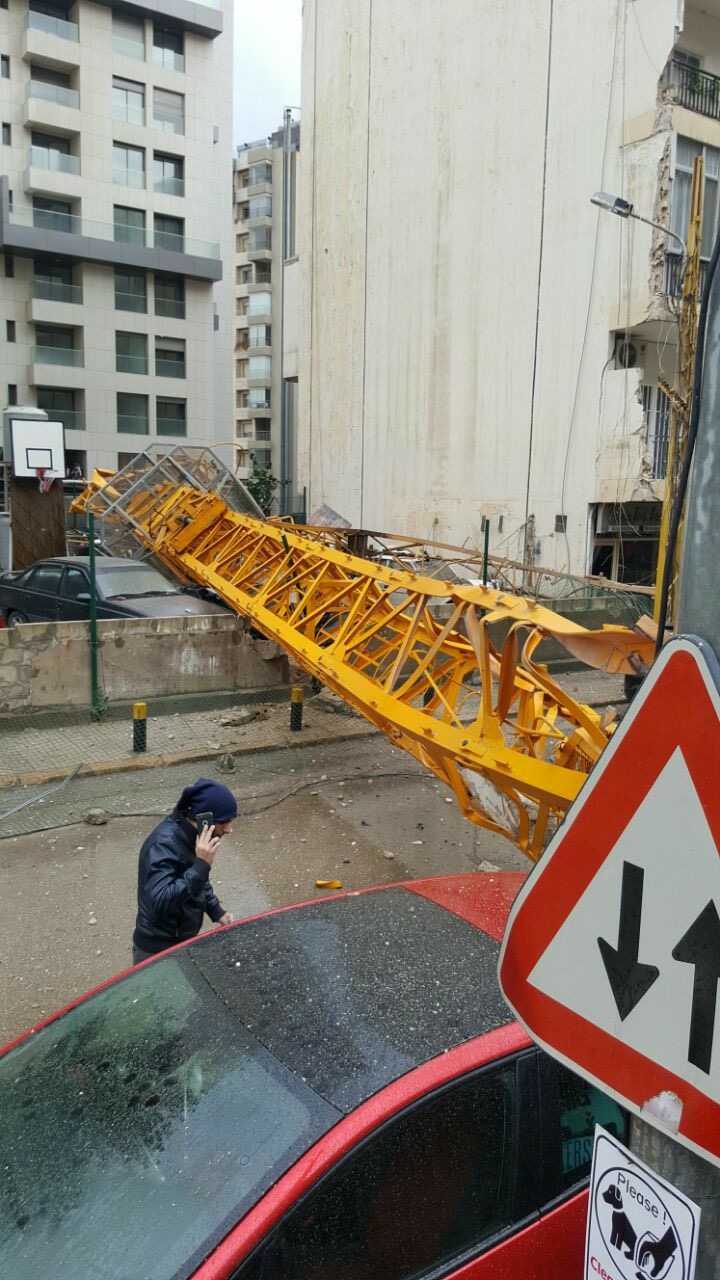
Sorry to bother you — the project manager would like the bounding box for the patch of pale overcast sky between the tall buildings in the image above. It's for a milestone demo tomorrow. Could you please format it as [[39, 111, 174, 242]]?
[[234, 0, 302, 146]]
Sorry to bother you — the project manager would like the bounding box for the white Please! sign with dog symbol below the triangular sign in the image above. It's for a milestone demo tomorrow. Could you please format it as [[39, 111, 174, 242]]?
[[585, 1125, 700, 1280]]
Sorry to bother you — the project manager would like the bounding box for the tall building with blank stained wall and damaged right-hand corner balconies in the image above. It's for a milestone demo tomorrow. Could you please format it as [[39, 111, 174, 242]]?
[[299, 0, 720, 581]]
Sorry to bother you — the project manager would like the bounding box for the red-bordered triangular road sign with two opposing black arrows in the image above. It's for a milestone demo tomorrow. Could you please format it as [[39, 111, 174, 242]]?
[[498, 637, 720, 1165]]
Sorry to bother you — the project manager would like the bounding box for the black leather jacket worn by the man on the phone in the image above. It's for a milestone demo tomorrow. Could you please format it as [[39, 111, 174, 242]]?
[[132, 809, 224, 955]]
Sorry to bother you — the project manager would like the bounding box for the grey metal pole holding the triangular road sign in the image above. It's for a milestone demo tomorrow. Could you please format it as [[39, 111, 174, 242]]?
[[630, 257, 720, 1280]]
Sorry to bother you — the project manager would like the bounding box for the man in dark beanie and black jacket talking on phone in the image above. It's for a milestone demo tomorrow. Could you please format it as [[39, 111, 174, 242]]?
[[132, 778, 237, 964]]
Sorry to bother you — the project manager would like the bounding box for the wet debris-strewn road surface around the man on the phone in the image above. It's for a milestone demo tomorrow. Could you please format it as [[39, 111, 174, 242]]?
[[0, 736, 517, 1044]]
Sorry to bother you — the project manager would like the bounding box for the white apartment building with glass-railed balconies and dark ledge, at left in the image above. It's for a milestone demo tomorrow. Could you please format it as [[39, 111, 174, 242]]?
[[0, 0, 233, 472]]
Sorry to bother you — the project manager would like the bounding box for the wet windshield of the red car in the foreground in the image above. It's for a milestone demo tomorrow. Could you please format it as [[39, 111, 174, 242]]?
[[0, 952, 338, 1280]]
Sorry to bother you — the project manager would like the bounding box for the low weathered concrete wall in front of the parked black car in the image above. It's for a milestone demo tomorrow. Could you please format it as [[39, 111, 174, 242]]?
[[0, 616, 290, 712]]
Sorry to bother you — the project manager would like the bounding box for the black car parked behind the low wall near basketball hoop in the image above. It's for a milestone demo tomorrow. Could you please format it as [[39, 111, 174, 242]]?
[[0, 556, 229, 627]]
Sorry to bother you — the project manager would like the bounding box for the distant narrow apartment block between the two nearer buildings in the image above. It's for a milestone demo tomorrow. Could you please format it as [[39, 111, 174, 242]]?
[[234, 118, 300, 512]]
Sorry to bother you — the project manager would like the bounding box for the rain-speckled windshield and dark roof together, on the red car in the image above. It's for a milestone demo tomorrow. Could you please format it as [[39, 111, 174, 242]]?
[[0, 873, 523, 1280]]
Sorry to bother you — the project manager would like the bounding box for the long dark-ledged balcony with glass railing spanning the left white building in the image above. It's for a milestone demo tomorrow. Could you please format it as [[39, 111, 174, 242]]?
[[0, 177, 223, 280]]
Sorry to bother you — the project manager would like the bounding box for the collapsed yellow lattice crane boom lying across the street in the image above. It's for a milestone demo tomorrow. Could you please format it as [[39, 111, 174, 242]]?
[[73, 448, 652, 859]]
